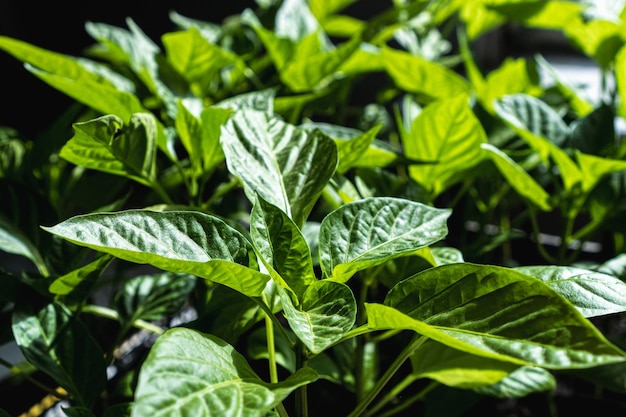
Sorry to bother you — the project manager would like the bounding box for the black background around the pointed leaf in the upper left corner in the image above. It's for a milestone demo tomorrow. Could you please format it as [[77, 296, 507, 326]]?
[[0, 0, 256, 138]]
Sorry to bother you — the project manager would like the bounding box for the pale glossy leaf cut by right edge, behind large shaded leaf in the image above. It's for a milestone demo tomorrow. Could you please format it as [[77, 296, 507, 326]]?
[[515, 265, 626, 317]]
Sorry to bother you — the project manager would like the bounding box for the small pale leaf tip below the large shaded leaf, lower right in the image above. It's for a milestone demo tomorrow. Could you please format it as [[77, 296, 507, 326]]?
[[476, 366, 556, 398]]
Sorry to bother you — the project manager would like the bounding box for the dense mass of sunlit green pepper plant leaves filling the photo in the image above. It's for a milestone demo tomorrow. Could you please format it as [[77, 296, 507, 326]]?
[[0, 0, 626, 417]]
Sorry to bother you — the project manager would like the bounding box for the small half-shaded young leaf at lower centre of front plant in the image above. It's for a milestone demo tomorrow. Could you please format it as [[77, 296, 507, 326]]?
[[279, 281, 356, 353]]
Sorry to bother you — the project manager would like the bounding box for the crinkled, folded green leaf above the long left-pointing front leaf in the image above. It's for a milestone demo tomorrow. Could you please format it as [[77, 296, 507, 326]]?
[[60, 113, 157, 186]]
